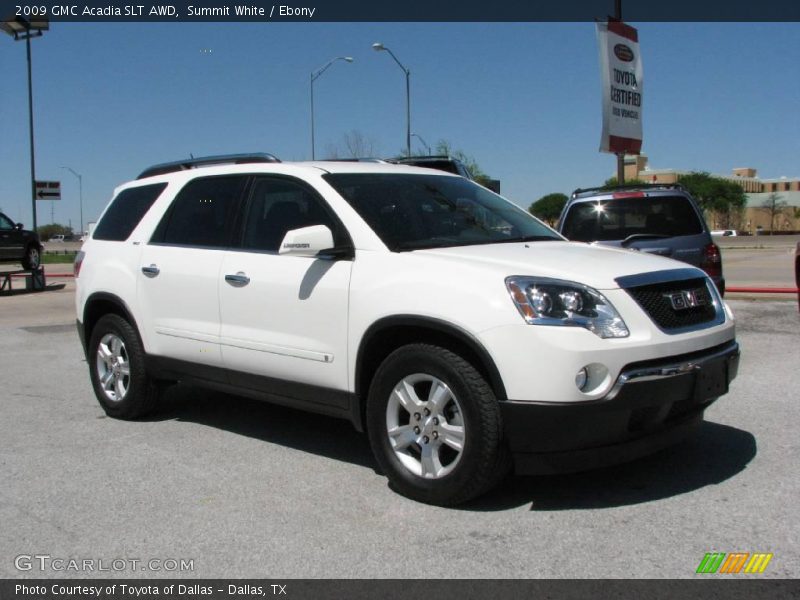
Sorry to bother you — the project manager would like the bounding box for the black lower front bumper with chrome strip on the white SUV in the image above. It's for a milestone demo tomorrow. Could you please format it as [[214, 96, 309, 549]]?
[[500, 341, 739, 474]]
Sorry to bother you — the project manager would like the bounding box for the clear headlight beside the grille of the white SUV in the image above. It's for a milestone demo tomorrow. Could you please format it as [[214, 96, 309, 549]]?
[[506, 275, 629, 338]]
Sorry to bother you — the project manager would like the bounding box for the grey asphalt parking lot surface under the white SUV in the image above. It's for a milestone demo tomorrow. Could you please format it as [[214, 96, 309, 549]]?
[[0, 264, 800, 579]]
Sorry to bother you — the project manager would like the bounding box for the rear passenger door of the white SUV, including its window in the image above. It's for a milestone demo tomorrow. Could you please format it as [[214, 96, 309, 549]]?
[[137, 175, 249, 372]]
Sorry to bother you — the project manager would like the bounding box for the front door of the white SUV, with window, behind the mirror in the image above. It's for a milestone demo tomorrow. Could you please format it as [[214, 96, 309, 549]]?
[[219, 176, 353, 396]]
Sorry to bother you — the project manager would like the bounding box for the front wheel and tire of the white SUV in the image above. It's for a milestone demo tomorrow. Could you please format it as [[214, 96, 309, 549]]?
[[367, 344, 510, 506]]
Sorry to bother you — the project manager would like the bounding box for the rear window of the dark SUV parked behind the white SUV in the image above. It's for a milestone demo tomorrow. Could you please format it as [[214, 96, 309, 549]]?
[[561, 196, 703, 242]]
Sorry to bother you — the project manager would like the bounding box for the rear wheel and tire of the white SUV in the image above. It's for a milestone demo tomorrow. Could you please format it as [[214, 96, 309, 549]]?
[[88, 314, 158, 419]]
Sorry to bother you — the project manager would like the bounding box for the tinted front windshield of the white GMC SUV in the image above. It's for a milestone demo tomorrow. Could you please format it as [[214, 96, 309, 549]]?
[[324, 173, 562, 252]]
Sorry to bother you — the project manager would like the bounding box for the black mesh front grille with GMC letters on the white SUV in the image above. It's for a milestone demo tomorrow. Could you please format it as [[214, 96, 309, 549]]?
[[625, 277, 718, 331]]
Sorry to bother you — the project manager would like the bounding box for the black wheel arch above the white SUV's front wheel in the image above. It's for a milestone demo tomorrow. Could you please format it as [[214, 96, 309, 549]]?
[[354, 315, 506, 429]]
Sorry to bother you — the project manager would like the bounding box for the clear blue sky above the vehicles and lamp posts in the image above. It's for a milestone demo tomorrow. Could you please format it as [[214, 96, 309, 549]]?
[[0, 23, 800, 229]]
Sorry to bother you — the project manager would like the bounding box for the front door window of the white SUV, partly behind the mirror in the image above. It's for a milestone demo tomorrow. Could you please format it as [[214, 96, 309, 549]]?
[[242, 178, 347, 252]]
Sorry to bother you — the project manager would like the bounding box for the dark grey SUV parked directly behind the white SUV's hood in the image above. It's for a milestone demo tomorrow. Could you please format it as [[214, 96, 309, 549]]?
[[558, 184, 725, 294]]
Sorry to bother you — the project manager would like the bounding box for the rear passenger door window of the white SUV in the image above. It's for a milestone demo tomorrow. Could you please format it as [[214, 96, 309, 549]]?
[[150, 175, 247, 248]]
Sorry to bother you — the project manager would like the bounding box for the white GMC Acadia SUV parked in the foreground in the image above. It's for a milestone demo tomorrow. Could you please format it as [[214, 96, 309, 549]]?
[[75, 156, 739, 505]]
